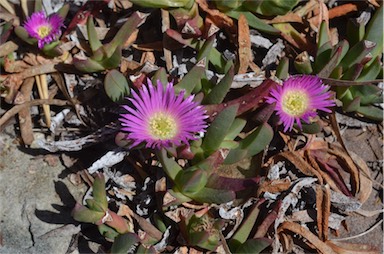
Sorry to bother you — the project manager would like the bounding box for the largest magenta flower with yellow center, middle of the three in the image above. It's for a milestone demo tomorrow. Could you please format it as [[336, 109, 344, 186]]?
[[119, 80, 208, 149]]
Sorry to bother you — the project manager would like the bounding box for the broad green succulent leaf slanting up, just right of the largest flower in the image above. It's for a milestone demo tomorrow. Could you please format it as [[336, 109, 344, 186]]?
[[201, 105, 238, 156]]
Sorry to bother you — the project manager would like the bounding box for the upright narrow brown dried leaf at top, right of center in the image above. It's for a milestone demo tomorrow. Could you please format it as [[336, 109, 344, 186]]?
[[238, 14, 253, 74]]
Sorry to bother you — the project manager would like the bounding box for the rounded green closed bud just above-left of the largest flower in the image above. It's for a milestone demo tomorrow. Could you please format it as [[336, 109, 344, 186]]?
[[104, 70, 129, 102]]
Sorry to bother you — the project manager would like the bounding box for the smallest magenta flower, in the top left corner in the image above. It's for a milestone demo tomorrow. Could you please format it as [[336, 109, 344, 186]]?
[[24, 11, 63, 49]]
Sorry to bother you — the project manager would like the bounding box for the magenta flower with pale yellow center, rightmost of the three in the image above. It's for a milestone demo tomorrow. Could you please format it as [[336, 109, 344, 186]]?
[[266, 75, 335, 131]]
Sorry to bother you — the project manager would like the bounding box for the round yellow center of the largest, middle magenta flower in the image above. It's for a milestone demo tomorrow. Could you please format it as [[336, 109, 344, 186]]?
[[148, 113, 177, 140]]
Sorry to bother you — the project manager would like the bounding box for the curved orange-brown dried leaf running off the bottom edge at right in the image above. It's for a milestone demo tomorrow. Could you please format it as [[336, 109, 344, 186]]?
[[278, 221, 336, 254]]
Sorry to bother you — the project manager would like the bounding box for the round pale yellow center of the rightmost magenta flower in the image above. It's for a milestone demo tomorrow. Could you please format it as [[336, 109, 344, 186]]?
[[282, 90, 309, 116]]
